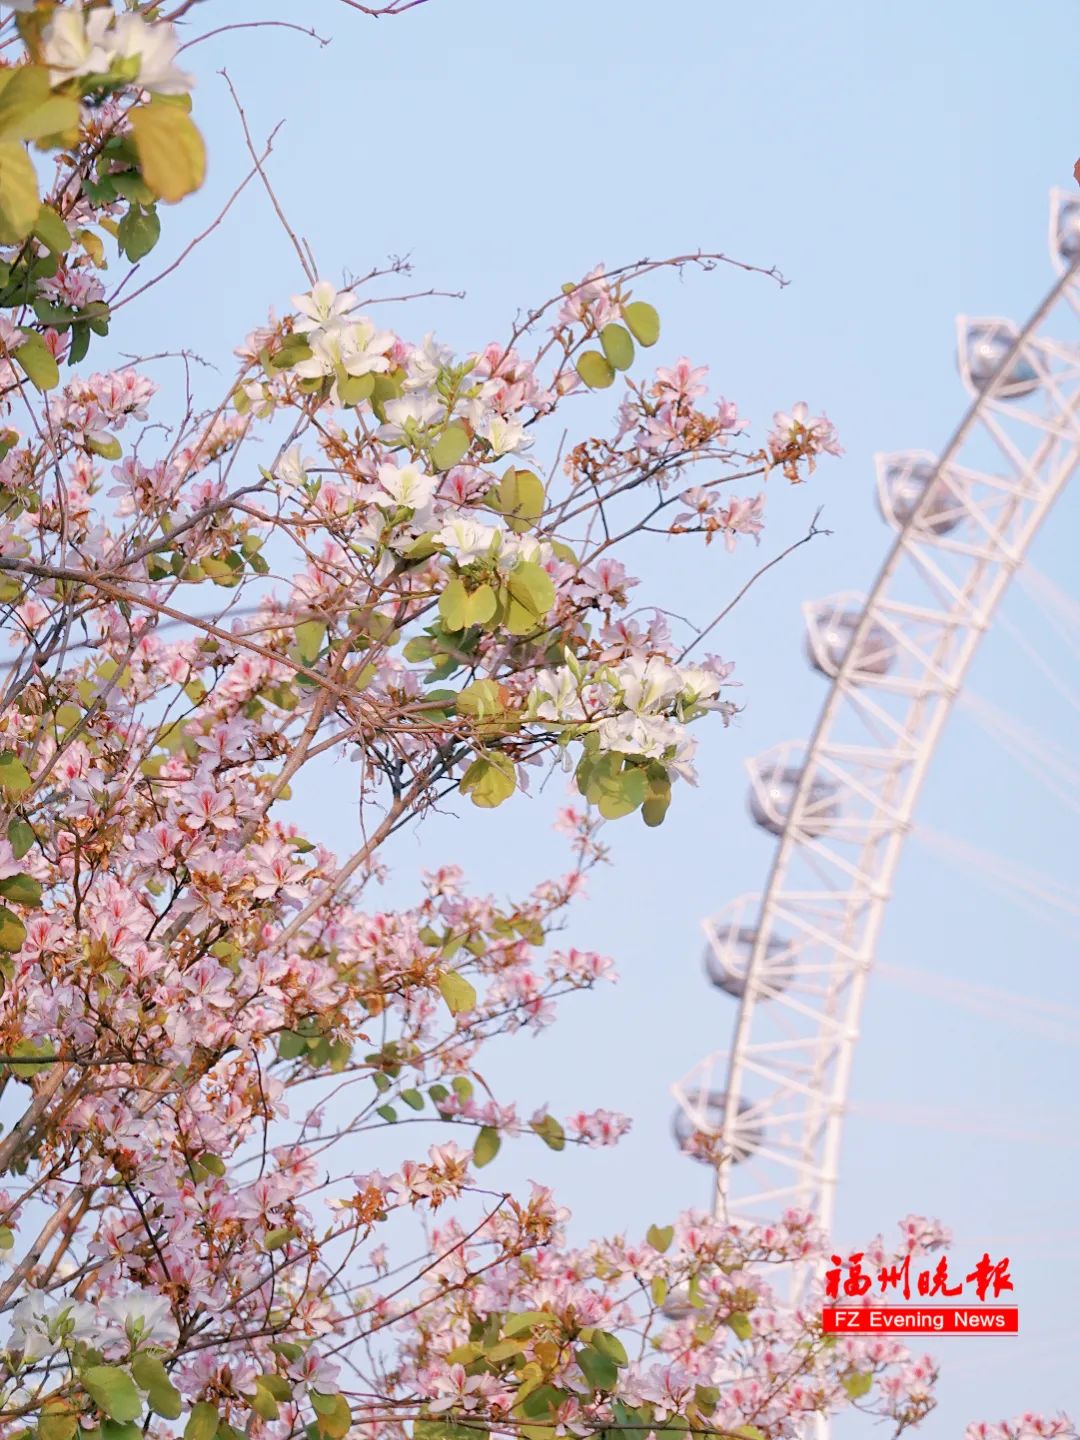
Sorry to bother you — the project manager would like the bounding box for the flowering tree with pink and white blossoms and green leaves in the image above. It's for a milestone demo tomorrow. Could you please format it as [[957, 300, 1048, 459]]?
[[0, 8, 1071, 1440]]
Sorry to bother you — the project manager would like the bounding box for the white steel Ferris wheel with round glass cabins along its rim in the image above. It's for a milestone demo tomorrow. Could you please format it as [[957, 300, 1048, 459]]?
[[672, 190, 1080, 1299]]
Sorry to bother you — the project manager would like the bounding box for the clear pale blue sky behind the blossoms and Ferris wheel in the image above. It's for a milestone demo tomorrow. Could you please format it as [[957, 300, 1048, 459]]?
[[114, 0, 1080, 1440]]
